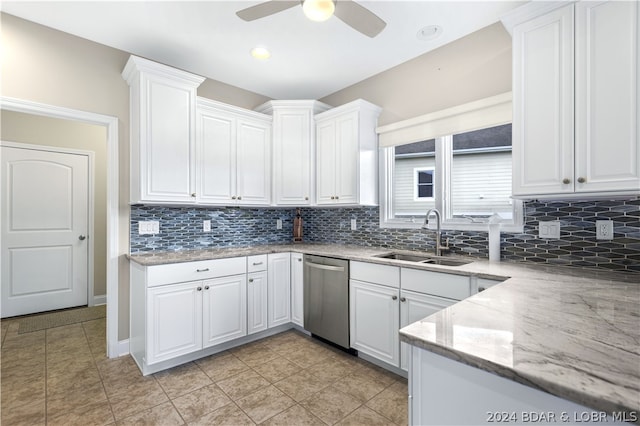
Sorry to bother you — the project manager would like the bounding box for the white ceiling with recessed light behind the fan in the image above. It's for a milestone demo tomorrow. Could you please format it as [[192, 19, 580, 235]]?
[[2, 0, 522, 99]]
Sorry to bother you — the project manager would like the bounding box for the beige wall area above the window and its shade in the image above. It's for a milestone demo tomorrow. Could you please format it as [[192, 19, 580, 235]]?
[[320, 23, 511, 125]]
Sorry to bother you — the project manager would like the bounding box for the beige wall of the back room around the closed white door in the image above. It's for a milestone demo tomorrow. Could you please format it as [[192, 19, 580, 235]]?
[[0, 111, 107, 296]]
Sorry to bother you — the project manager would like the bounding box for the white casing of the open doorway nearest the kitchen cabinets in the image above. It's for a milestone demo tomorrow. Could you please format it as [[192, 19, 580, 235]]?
[[0, 96, 120, 358]]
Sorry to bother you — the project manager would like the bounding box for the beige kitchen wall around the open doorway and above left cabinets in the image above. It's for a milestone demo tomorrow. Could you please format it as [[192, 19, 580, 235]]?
[[0, 13, 268, 340]]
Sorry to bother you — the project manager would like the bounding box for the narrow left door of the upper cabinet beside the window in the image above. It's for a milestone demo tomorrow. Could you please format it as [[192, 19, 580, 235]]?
[[316, 120, 337, 204]]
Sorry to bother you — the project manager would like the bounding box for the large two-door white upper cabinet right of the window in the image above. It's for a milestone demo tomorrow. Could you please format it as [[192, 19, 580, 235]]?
[[505, 1, 640, 197]]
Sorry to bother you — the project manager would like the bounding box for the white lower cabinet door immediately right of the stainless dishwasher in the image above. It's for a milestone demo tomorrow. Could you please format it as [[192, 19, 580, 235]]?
[[349, 280, 400, 366]]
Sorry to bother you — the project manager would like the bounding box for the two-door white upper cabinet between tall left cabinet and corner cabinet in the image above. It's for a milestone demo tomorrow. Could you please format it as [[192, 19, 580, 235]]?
[[196, 98, 271, 205]]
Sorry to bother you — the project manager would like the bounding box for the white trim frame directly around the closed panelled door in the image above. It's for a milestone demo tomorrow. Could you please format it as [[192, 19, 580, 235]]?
[[0, 141, 95, 312]]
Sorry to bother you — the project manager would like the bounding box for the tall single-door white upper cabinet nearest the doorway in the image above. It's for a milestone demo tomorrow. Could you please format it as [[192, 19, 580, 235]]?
[[122, 56, 204, 203]]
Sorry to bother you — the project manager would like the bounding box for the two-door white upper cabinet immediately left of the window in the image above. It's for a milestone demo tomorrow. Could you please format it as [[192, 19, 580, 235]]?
[[315, 100, 381, 205]]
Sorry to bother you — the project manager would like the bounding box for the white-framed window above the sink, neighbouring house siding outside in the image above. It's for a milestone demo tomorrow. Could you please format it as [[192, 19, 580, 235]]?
[[381, 124, 522, 231]]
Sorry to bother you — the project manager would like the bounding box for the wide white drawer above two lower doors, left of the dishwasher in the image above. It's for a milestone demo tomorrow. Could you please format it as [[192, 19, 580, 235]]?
[[147, 257, 247, 287]]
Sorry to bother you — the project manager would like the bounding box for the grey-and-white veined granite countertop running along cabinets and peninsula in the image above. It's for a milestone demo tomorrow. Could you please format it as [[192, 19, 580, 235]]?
[[129, 244, 640, 414]]
